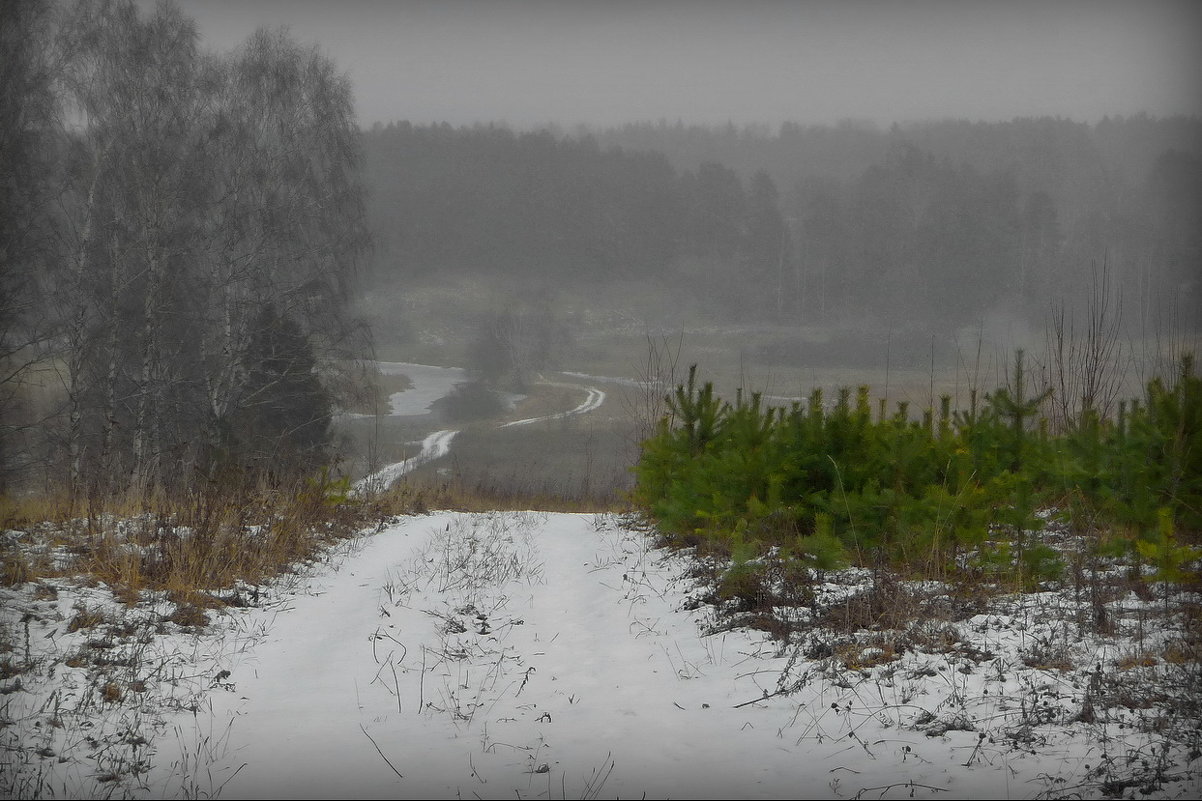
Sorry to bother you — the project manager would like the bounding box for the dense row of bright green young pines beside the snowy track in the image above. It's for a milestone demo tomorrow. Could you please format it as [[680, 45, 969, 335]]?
[[635, 351, 1202, 589]]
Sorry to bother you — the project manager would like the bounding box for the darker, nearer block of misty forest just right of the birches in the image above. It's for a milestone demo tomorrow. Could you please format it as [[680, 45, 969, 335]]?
[[364, 123, 784, 312]]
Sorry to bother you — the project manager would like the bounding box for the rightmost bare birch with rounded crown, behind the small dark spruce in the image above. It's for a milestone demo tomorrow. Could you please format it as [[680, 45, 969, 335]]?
[[204, 29, 368, 473]]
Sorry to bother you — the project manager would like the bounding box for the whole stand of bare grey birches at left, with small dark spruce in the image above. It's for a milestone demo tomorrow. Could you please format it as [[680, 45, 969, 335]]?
[[0, 0, 368, 497]]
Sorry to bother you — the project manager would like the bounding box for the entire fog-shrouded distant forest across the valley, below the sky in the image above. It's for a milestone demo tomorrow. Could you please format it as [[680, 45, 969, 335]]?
[[363, 115, 1202, 328]]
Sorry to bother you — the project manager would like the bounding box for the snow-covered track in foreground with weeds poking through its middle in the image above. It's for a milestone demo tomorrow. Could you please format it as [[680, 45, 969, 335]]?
[[155, 512, 827, 799]]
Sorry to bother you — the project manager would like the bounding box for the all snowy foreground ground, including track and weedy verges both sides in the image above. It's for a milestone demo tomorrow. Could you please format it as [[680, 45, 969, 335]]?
[[0, 512, 1202, 799]]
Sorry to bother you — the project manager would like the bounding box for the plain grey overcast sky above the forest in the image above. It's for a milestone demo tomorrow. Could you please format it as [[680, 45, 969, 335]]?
[[167, 0, 1202, 127]]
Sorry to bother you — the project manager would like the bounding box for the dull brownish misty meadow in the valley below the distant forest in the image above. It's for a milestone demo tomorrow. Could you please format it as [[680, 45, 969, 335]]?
[[341, 271, 1198, 508]]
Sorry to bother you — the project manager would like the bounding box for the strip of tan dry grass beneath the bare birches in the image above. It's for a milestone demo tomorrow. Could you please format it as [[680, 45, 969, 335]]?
[[0, 480, 394, 605]]
